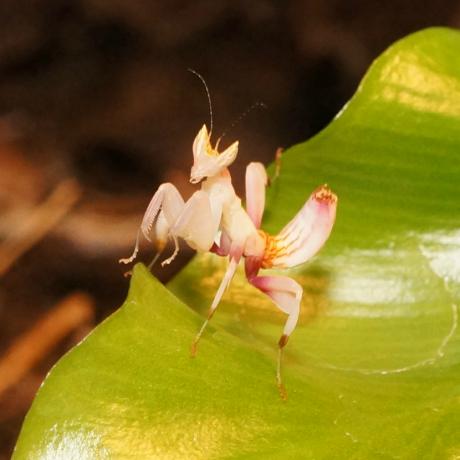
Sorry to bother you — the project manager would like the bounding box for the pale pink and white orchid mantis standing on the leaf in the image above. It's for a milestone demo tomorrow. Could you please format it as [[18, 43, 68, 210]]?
[[120, 125, 337, 398]]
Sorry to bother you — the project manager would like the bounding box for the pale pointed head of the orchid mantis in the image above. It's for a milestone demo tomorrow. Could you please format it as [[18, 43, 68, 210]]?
[[190, 125, 238, 184]]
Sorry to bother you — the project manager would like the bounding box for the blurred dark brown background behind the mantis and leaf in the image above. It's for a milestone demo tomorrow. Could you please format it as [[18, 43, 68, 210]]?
[[0, 0, 460, 459]]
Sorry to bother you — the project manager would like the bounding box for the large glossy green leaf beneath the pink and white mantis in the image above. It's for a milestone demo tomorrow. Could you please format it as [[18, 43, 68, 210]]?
[[14, 29, 460, 459]]
